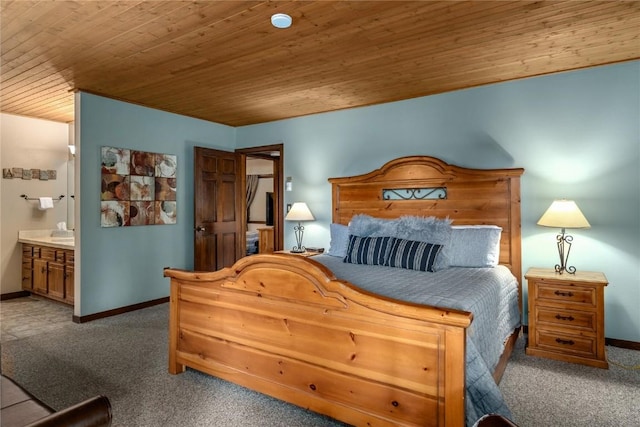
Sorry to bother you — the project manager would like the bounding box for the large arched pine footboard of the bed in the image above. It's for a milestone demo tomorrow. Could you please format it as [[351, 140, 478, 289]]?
[[164, 254, 472, 426]]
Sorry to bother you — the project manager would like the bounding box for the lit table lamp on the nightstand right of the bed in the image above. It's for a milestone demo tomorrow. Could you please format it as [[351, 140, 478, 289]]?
[[538, 199, 591, 274]]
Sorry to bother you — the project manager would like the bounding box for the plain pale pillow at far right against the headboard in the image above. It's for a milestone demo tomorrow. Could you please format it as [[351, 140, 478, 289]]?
[[444, 225, 502, 267]]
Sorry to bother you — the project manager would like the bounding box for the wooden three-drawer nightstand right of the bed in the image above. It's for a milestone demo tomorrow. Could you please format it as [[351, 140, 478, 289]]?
[[524, 268, 609, 369]]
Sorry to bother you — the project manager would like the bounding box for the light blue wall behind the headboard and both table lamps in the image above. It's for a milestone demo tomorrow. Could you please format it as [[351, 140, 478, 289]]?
[[236, 61, 640, 342]]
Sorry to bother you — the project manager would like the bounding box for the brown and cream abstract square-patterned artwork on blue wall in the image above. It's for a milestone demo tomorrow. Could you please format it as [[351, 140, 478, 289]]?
[[100, 147, 178, 227]]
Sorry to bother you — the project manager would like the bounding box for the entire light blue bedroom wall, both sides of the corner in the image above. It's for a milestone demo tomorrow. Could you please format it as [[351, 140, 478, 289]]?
[[77, 61, 640, 342]]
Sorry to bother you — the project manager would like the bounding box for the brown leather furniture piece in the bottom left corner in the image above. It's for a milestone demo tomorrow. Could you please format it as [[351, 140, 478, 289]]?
[[0, 375, 112, 427]]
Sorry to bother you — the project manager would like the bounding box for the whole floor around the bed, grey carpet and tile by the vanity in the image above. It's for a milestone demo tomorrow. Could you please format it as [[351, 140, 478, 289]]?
[[0, 298, 640, 427]]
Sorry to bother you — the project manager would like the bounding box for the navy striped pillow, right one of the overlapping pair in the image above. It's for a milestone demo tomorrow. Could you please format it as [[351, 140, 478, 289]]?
[[384, 239, 442, 271]]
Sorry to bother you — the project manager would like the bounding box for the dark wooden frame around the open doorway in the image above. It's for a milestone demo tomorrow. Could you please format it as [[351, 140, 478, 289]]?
[[236, 144, 284, 251]]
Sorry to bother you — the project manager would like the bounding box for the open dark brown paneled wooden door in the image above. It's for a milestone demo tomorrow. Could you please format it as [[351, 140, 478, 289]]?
[[194, 147, 245, 271]]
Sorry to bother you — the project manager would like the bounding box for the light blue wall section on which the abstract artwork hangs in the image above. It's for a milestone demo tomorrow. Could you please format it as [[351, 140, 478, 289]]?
[[76, 93, 235, 316]]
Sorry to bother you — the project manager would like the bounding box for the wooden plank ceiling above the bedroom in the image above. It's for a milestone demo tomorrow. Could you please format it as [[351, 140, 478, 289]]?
[[0, 0, 640, 126]]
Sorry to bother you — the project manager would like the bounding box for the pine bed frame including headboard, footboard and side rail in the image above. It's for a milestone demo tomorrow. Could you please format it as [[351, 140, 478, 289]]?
[[164, 156, 523, 426]]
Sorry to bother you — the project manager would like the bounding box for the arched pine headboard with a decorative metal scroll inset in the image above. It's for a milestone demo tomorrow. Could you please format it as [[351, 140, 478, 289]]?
[[329, 156, 524, 294]]
